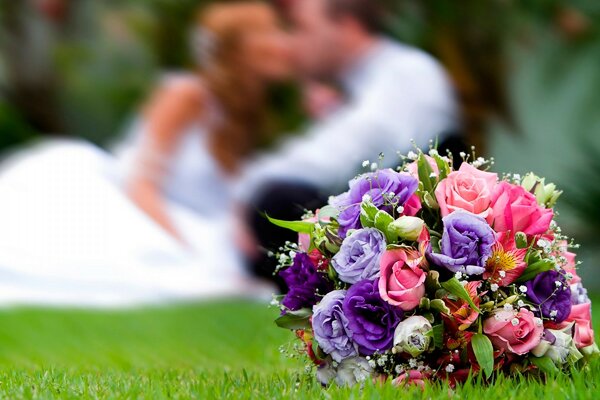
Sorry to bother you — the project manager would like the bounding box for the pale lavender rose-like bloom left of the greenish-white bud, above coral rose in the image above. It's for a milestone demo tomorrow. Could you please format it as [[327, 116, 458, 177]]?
[[331, 228, 386, 283]]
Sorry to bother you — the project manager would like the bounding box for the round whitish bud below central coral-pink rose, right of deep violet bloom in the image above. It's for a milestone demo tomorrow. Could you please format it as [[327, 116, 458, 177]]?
[[394, 315, 433, 357]]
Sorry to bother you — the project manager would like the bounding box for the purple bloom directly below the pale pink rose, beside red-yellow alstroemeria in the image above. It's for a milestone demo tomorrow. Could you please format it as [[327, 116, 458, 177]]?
[[427, 210, 496, 275]]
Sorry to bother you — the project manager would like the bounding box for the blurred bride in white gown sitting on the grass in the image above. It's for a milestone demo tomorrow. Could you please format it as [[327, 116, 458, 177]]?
[[0, 2, 290, 306]]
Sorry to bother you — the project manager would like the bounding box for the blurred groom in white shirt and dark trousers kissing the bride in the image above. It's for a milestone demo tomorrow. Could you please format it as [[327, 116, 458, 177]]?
[[238, 0, 462, 286]]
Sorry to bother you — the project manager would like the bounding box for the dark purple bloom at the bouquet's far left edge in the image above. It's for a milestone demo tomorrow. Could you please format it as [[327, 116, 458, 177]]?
[[279, 253, 331, 311]]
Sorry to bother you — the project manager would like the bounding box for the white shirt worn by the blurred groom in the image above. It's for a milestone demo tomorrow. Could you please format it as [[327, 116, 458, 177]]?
[[236, 39, 459, 200]]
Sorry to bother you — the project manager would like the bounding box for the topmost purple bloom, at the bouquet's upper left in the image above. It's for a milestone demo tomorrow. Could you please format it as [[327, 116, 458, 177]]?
[[331, 168, 419, 238]]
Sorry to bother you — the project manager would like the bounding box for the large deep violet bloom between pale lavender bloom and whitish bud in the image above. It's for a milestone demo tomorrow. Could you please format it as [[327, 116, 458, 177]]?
[[343, 279, 403, 356]]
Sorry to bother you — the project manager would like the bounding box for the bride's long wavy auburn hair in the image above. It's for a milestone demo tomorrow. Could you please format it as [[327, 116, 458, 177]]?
[[195, 1, 274, 173]]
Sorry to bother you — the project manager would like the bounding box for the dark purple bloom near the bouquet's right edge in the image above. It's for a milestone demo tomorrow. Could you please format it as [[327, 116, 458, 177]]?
[[525, 270, 571, 323]]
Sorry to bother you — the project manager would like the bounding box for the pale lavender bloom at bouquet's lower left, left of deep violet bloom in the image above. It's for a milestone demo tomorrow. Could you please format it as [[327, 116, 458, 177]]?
[[312, 290, 356, 362]]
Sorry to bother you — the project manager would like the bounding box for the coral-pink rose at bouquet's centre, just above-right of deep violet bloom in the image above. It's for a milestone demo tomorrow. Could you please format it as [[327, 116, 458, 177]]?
[[379, 249, 427, 311]]
